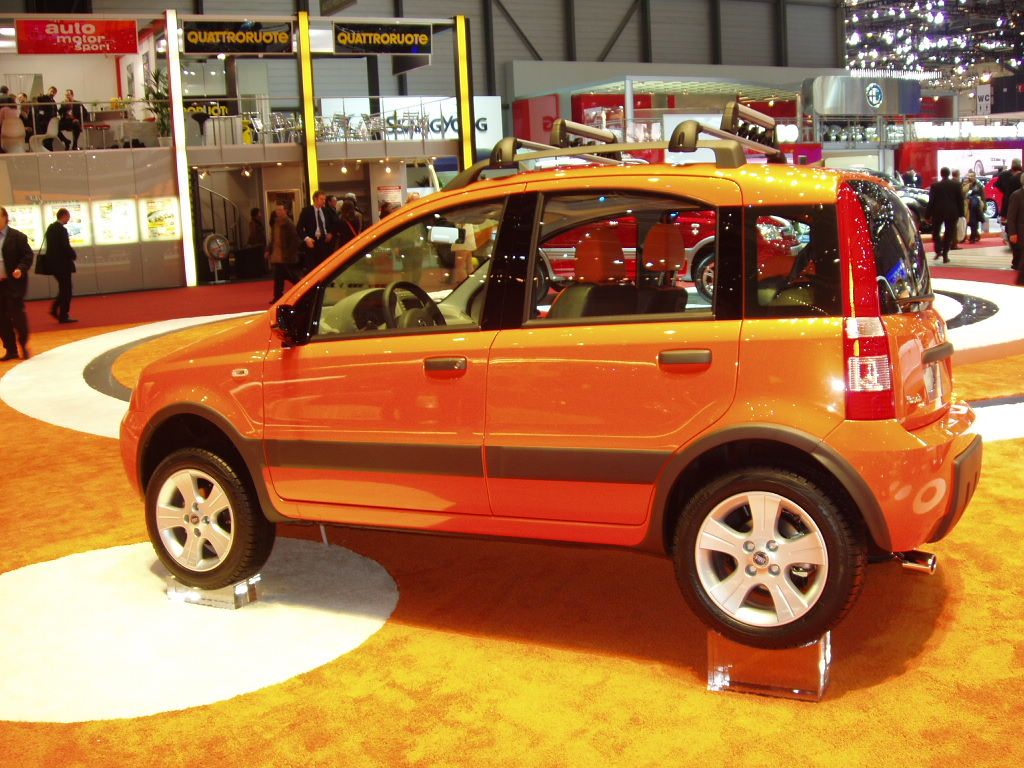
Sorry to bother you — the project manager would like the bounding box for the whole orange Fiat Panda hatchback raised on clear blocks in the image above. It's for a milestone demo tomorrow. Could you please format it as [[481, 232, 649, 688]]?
[[121, 104, 982, 647]]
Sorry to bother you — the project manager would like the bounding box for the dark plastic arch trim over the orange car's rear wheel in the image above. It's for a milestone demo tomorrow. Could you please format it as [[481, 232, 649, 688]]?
[[640, 424, 891, 554]]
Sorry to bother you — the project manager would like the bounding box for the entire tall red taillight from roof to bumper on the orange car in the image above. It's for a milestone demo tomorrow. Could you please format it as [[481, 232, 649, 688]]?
[[837, 183, 896, 421]]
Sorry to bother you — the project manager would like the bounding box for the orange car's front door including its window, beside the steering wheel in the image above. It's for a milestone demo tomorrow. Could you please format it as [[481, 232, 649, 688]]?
[[264, 197, 512, 521]]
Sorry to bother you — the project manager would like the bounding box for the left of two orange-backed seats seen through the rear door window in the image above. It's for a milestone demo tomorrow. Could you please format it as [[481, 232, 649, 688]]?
[[548, 227, 637, 318]]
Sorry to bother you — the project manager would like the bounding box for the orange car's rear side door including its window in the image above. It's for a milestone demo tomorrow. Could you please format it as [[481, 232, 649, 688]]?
[[484, 176, 741, 525]]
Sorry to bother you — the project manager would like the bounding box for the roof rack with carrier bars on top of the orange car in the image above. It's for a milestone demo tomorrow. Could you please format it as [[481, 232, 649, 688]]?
[[444, 101, 785, 189]]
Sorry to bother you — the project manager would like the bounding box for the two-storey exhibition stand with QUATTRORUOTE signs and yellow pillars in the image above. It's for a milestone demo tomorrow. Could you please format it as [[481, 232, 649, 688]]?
[[0, 11, 479, 298]]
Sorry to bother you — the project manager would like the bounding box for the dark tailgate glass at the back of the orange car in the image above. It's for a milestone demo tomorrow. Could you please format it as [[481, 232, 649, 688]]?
[[849, 180, 932, 314]]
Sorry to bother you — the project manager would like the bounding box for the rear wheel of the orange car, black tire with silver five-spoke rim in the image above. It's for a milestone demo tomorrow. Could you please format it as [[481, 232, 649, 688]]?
[[673, 467, 867, 648]]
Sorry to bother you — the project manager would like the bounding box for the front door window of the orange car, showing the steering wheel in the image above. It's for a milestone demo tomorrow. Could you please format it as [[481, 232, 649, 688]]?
[[313, 199, 504, 339]]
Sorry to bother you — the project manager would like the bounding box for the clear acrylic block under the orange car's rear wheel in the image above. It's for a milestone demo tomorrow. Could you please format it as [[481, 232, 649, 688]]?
[[708, 631, 831, 701]]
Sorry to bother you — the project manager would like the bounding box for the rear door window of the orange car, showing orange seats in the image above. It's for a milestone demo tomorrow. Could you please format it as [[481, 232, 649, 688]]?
[[528, 191, 716, 323]]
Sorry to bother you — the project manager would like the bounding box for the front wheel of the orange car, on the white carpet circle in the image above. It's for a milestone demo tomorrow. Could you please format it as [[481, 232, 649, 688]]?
[[145, 449, 275, 589]]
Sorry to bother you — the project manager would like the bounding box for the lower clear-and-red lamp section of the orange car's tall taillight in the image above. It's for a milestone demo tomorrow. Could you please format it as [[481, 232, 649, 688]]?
[[843, 317, 896, 421]]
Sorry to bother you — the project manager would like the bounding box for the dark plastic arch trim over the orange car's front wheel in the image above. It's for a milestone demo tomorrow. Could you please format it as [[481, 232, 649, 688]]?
[[137, 403, 288, 522]]
